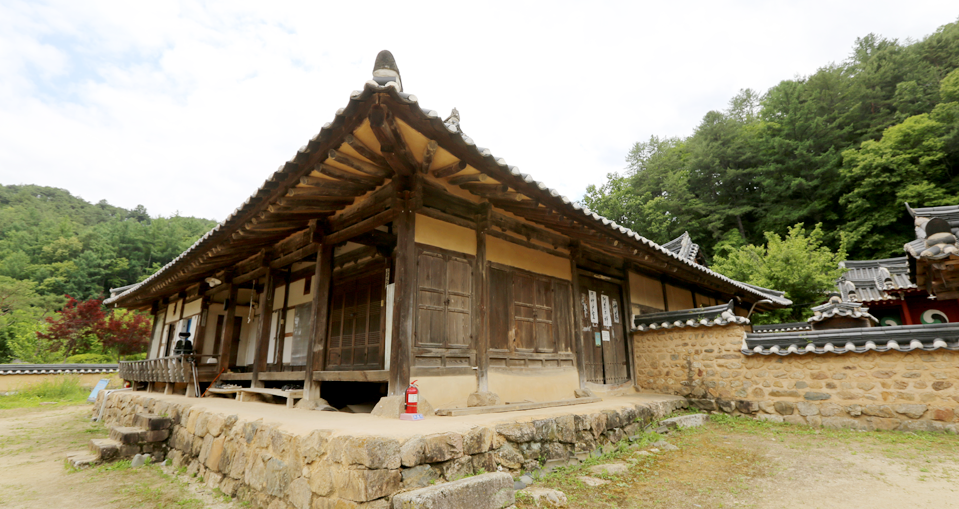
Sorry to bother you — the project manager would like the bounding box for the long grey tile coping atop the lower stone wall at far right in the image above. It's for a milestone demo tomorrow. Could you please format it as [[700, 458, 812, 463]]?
[[742, 323, 959, 355]]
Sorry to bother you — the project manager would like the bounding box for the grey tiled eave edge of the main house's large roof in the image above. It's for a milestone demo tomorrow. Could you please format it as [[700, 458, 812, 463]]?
[[104, 56, 792, 306]]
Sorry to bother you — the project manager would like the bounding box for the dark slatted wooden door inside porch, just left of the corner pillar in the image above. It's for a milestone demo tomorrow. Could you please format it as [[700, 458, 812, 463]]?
[[326, 272, 385, 371]]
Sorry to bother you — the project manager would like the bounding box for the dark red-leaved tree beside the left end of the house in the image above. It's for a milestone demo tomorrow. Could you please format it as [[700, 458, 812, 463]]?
[[37, 295, 151, 357]]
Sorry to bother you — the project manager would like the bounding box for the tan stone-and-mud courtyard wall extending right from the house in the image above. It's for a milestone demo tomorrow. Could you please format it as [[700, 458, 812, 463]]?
[[633, 325, 959, 433]]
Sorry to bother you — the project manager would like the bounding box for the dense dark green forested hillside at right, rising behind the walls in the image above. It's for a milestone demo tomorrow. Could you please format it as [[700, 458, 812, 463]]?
[[585, 18, 959, 259]]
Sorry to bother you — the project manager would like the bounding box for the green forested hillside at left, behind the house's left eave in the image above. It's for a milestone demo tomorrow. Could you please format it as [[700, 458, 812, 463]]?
[[0, 185, 216, 362]]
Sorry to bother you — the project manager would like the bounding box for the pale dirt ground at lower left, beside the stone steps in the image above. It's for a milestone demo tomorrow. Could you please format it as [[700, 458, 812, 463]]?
[[0, 405, 234, 509]]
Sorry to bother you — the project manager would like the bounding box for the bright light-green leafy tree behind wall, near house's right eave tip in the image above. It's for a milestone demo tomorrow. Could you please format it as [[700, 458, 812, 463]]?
[[712, 224, 846, 323]]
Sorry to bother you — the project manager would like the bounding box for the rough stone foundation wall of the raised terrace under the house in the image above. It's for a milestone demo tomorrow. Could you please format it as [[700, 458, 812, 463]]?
[[94, 392, 686, 509]]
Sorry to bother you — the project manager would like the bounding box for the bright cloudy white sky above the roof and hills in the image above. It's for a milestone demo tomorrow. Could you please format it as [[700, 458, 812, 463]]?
[[0, 0, 959, 221]]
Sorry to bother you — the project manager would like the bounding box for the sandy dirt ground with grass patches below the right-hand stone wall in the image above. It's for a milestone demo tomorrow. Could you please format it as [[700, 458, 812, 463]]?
[[518, 412, 959, 509]]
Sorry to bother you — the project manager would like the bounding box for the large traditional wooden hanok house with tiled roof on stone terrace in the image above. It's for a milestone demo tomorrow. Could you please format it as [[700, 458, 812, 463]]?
[[107, 51, 790, 407]]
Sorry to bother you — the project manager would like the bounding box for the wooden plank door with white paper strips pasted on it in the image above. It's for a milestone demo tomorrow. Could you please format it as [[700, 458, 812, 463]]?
[[578, 277, 629, 384]]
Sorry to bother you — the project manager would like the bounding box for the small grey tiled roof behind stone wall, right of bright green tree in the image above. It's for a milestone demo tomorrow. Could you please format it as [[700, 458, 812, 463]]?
[[836, 256, 917, 302]]
